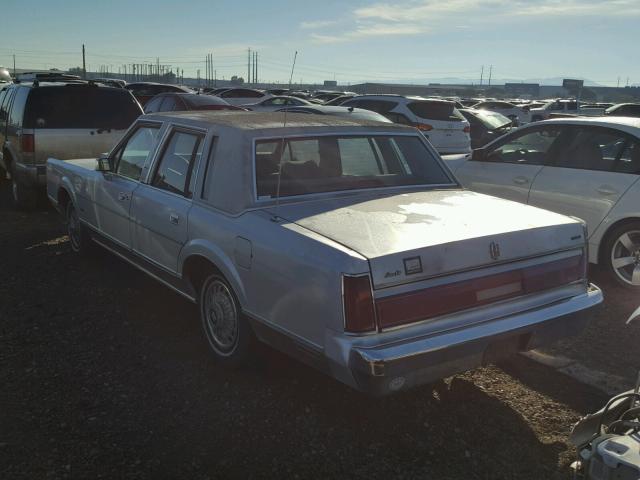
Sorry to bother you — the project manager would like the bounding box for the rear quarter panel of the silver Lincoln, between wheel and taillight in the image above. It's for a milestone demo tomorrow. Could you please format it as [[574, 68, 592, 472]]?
[[180, 205, 368, 349]]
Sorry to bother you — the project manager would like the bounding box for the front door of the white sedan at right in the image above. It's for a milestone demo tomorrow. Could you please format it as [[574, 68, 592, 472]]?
[[455, 125, 561, 203]]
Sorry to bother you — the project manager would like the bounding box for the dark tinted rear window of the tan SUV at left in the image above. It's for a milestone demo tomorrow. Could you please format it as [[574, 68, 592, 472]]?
[[25, 85, 142, 130]]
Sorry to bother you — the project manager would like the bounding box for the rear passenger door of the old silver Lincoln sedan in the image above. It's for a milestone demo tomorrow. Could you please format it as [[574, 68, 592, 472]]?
[[126, 128, 205, 273]]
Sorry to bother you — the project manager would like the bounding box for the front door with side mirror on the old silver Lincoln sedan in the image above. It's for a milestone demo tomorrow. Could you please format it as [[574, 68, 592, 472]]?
[[95, 123, 161, 249]]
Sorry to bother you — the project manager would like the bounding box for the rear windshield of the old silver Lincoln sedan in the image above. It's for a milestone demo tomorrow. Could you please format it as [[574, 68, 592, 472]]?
[[255, 135, 454, 198]]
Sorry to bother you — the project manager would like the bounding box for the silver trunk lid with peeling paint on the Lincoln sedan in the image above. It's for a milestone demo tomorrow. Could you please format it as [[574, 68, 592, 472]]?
[[272, 189, 585, 288]]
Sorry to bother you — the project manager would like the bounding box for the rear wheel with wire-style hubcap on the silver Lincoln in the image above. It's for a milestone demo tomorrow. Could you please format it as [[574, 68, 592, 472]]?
[[198, 273, 254, 368]]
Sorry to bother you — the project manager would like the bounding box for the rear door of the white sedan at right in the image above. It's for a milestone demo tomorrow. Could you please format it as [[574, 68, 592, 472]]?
[[529, 125, 638, 233]]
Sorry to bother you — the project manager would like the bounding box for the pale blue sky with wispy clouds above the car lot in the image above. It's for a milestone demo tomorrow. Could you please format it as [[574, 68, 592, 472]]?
[[0, 0, 640, 85]]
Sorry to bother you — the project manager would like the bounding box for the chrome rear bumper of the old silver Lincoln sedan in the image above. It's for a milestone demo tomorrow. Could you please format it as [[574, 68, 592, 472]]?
[[349, 285, 603, 395]]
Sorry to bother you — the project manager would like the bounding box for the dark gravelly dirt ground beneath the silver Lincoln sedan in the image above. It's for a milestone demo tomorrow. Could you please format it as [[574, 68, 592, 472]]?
[[0, 189, 640, 480]]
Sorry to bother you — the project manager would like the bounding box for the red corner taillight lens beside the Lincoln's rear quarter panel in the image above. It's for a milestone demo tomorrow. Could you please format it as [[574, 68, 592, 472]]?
[[342, 275, 376, 333]]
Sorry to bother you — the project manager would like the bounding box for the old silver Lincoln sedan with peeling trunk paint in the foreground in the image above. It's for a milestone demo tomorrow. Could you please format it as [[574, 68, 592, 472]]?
[[47, 112, 602, 394]]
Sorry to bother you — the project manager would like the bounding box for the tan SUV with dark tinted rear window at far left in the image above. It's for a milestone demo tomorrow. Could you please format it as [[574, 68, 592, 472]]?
[[0, 80, 142, 208]]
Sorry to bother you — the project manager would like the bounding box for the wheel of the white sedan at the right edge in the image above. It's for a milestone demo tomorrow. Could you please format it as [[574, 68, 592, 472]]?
[[602, 221, 640, 291]]
